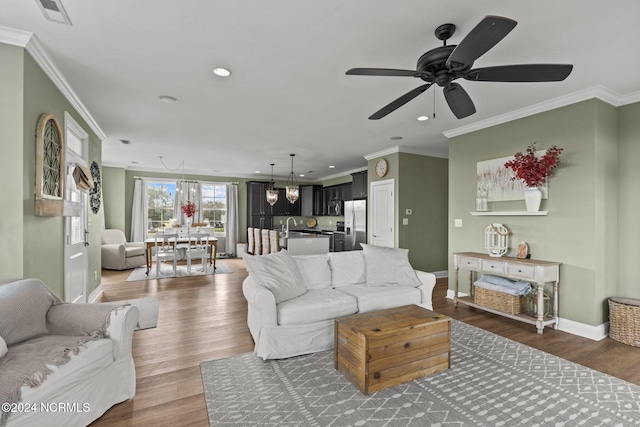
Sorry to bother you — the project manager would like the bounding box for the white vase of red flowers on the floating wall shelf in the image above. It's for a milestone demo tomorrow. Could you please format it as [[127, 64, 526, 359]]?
[[504, 142, 563, 212]]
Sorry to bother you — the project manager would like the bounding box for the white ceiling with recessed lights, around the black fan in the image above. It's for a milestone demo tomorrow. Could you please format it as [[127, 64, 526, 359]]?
[[0, 0, 640, 180]]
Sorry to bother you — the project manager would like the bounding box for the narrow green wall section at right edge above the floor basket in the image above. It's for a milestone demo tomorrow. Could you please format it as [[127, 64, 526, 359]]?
[[616, 103, 640, 298]]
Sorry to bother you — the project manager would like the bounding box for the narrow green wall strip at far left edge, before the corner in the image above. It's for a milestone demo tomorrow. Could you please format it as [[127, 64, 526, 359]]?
[[0, 43, 24, 280]]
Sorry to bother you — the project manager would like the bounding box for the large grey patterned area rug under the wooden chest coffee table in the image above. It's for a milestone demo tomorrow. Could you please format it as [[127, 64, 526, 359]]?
[[200, 320, 640, 427]]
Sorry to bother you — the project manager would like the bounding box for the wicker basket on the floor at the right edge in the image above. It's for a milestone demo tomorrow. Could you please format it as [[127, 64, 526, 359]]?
[[609, 298, 640, 347]]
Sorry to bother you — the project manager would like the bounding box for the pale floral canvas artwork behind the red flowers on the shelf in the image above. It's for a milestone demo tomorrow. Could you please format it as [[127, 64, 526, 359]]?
[[476, 150, 548, 202]]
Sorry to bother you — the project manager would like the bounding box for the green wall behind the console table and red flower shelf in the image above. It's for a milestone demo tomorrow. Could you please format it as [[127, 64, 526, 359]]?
[[449, 99, 624, 325]]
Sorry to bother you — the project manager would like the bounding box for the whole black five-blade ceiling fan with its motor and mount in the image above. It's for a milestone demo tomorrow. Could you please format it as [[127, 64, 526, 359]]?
[[347, 16, 573, 120]]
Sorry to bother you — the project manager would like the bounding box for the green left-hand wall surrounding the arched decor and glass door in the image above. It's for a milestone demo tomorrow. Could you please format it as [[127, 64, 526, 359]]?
[[0, 44, 102, 298]]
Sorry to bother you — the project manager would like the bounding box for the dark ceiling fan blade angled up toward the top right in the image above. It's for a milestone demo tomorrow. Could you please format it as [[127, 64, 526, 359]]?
[[447, 16, 518, 70]]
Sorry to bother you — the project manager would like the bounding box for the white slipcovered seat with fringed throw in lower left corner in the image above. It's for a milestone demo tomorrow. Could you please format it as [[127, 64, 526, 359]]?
[[0, 279, 139, 427]]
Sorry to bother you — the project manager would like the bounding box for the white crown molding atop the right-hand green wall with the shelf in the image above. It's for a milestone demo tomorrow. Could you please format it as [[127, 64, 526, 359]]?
[[443, 86, 640, 139]]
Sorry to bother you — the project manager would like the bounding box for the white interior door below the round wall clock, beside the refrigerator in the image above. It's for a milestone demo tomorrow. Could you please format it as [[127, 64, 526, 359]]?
[[369, 179, 395, 248]]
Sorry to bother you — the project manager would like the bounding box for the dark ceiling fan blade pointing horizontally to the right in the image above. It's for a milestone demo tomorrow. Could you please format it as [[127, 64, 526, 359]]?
[[464, 64, 573, 82]]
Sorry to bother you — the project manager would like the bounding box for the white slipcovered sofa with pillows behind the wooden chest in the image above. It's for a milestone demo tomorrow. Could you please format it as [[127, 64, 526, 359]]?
[[242, 245, 436, 360]]
